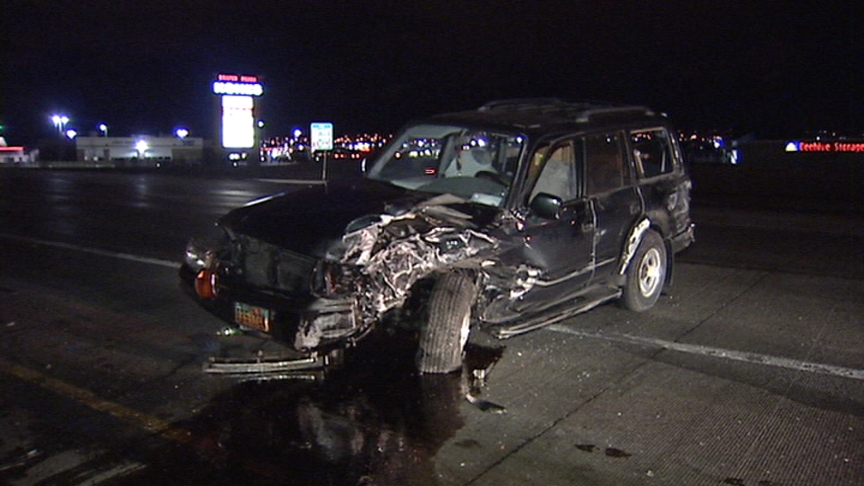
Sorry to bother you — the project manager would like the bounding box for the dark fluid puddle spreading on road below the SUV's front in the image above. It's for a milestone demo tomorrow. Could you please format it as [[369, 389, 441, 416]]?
[[118, 336, 503, 486]]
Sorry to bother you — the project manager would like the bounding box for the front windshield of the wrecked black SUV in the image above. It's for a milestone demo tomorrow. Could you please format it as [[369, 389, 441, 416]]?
[[369, 125, 525, 206]]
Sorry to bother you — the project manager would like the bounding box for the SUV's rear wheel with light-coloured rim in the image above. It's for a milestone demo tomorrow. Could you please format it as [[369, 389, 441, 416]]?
[[621, 230, 667, 312]]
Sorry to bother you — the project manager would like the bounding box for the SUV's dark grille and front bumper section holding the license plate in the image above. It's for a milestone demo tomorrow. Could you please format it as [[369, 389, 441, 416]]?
[[180, 235, 371, 351]]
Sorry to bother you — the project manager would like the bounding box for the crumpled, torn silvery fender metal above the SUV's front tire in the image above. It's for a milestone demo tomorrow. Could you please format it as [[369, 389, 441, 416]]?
[[294, 195, 516, 349]]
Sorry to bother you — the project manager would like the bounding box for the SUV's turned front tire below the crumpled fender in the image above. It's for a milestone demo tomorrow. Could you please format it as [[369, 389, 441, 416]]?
[[417, 273, 476, 373]]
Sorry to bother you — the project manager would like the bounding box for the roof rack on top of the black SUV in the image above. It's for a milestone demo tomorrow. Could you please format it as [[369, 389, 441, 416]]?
[[478, 98, 655, 123]]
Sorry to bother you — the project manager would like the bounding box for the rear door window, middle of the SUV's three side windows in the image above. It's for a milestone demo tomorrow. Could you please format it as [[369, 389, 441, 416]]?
[[585, 134, 624, 195]]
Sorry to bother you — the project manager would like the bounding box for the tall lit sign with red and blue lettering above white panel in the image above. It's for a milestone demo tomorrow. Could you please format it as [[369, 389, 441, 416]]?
[[212, 74, 264, 149]]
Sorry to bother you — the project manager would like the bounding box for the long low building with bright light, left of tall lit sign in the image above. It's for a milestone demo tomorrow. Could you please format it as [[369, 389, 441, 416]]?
[[75, 135, 204, 165]]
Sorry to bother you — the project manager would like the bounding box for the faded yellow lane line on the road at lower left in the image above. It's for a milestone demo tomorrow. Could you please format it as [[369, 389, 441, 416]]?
[[0, 358, 192, 444]]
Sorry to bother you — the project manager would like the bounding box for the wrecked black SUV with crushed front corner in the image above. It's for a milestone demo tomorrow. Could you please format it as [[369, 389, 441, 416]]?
[[181, 99, 693, 373]]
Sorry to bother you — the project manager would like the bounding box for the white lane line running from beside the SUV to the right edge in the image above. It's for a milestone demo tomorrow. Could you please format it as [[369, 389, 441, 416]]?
[[546, 324, 864, 380]]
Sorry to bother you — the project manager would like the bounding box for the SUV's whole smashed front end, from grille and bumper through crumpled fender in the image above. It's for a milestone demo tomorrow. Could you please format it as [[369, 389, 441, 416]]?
[[180, 191, 497, 352]]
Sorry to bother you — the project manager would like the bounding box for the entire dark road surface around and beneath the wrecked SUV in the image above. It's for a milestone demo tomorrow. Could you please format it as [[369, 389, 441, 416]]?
[[0, 170, 864, 486]]
